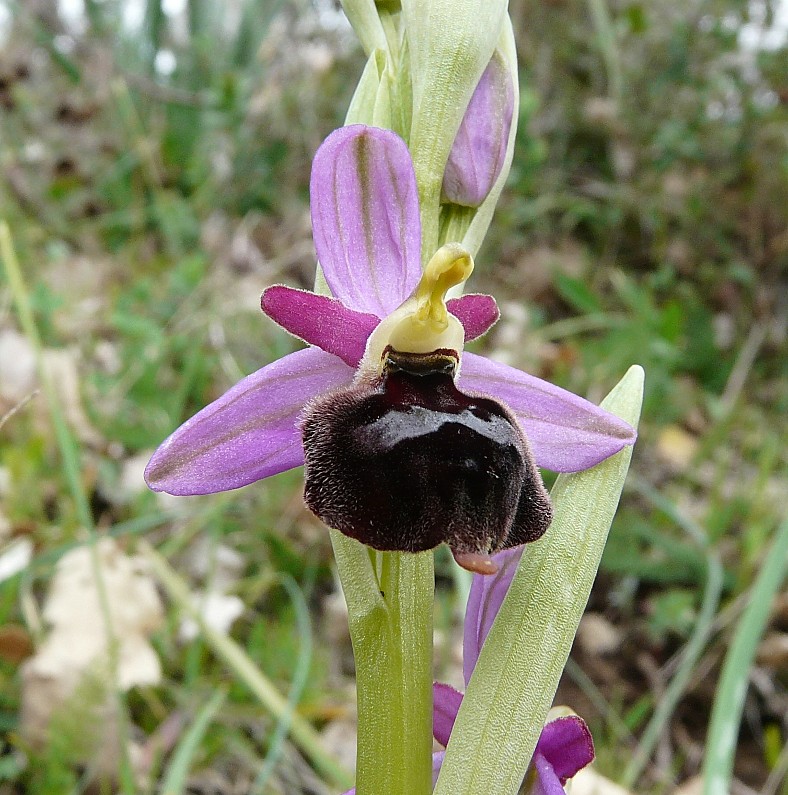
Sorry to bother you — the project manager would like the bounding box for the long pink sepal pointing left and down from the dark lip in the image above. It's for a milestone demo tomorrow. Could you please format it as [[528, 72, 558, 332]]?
[[145, 348, 353, 495]]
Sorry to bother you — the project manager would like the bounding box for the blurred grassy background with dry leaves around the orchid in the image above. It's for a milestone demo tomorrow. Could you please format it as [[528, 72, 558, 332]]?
[[0, 0, 788, 795]]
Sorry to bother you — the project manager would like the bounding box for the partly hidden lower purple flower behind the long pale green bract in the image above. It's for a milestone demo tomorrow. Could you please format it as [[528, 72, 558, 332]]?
[[433, 547, 594, 795]]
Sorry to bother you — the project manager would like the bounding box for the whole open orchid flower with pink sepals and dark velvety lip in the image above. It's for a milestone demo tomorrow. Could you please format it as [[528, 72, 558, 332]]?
[[145, 125, 635, 572]]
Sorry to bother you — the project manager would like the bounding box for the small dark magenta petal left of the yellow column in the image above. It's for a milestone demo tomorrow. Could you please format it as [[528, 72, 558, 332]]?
[[260, 285, 380, 367]]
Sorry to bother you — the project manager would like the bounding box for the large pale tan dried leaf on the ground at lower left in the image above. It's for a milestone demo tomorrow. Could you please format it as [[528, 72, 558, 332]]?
[[20, 538, 163, 771]]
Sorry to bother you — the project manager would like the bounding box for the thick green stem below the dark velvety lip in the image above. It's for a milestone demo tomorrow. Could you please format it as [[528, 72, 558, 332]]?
[[331, 531, 434, 795]]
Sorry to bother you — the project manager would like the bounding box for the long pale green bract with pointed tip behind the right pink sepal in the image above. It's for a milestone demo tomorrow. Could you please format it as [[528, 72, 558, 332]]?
[[435, 367, 643, 795]]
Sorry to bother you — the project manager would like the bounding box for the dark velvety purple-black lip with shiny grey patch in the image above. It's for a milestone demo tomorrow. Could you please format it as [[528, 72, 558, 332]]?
[[303, 351, 552, 554]]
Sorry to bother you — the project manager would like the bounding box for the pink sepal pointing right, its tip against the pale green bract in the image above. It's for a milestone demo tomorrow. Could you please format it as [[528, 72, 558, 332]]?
[[459, 353, 637, 472]]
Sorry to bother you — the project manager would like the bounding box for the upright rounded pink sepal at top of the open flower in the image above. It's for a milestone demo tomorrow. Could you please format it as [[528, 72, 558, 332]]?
[[310, 124, 421, 317]]
